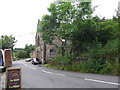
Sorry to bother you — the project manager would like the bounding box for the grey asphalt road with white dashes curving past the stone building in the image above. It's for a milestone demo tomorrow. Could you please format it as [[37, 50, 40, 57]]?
[[2, 60, 119, 88]]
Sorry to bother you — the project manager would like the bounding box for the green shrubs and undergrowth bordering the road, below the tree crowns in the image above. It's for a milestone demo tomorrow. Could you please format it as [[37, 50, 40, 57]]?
[[48, 40, 120, 75]]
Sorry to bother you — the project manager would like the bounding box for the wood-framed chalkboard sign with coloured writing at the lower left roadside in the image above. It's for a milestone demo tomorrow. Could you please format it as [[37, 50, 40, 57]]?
[[6, 68, 21, 89]]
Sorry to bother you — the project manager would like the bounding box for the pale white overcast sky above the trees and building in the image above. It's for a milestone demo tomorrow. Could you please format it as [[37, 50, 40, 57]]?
[[0, 0, 120, 48]]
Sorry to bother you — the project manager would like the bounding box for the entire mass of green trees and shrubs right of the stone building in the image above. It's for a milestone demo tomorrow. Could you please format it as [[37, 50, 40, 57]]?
[[38, 2, 120, 75]]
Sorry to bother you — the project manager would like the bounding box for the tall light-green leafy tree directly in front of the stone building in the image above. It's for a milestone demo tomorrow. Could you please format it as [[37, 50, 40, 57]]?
[[39, 2, 93, 55]]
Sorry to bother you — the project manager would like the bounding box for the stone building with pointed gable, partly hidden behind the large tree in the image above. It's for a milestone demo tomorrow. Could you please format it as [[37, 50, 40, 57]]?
[[33, 20, 70, 64]]
